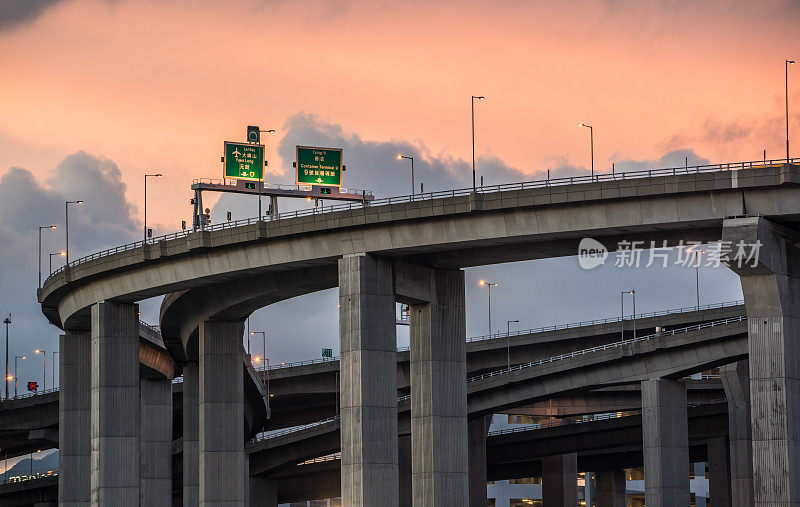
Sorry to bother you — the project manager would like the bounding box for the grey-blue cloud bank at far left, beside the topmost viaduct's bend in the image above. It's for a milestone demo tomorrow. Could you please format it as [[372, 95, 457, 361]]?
[[0, 152, 139, 387]]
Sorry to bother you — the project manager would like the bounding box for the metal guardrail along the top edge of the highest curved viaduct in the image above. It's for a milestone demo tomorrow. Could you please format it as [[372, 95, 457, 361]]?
[[45, 158, 800, 285]]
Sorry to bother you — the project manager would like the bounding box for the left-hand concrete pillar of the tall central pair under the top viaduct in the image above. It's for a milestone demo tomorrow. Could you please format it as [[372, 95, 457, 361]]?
[[339, 254, 399, 507]]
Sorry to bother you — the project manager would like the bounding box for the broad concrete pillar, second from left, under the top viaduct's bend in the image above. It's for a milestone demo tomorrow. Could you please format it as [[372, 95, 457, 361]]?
[[92, 301, 141, 506]]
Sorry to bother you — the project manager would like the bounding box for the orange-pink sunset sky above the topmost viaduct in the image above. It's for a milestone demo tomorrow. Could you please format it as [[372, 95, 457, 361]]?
[[0, 0, 800, 388]]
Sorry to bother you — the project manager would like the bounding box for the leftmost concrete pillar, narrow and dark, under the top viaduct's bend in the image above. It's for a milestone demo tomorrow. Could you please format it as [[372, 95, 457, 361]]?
[[58, 332, 92, 507]]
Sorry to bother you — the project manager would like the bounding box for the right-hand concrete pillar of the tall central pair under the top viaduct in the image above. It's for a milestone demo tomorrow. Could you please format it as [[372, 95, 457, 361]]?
[[410, 270, 469, 506]]
